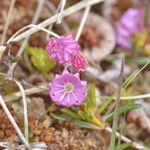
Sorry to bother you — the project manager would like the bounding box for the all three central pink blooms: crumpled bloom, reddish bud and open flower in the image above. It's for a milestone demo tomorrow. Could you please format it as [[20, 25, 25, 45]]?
[[46, 35, 87, 107]]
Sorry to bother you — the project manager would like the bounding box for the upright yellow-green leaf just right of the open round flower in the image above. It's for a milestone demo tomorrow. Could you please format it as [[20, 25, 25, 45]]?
[[83, 84, 97, 113]]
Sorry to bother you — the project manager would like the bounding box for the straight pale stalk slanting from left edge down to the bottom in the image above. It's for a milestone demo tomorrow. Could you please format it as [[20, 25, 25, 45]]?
[[0, 95, 30, 149]]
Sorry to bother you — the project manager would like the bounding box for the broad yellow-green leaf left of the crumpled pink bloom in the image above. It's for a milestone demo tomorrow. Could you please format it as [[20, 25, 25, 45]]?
[[28, 47, 55, 74]]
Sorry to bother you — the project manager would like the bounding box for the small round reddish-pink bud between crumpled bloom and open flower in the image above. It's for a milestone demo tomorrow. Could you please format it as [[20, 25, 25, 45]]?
[[71, 53, 86, 71]]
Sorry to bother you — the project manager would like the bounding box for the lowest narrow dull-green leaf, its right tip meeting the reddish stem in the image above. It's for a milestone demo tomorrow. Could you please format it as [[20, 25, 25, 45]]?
[[73, 120, 100, 130]]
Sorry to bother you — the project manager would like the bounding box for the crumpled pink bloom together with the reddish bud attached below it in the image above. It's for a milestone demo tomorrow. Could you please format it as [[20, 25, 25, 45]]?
[[46, 35, 86, 71]]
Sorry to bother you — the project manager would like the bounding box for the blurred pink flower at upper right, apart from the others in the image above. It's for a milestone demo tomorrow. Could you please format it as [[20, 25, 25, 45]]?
[[117, 8, 144, 50]]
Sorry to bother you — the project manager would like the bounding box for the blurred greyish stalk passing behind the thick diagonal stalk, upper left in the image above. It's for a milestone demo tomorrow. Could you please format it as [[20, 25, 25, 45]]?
[[10, 0, 45, 77]]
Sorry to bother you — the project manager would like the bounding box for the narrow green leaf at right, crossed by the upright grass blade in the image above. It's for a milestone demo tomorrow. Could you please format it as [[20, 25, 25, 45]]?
[[104, 104, 142, 122]]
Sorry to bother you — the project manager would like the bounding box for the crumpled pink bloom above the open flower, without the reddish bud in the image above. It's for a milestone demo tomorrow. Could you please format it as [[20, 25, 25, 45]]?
[[46, 35, 80, 63]]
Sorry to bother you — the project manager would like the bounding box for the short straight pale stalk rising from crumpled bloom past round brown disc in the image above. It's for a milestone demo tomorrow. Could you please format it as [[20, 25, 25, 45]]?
[[75, 6, 91, 41]]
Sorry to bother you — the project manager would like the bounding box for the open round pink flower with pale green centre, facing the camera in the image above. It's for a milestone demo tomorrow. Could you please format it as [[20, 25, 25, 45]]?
[[49, 70, 87, 107]]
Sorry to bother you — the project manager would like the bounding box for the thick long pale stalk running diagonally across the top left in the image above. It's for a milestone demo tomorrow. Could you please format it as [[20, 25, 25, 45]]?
[[7, 0, 103, 44]]
